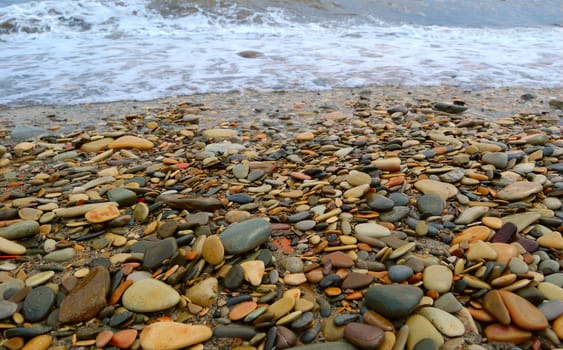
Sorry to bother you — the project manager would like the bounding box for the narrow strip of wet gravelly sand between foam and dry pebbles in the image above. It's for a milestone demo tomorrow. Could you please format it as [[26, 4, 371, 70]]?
[[0, 85, 563, 132]]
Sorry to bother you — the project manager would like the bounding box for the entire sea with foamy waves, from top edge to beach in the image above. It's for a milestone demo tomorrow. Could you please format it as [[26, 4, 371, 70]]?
[[0, 0, 563, 106]]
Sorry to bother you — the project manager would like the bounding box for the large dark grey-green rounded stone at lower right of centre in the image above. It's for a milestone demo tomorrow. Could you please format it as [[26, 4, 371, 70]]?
[[365, 284, 422, 318]]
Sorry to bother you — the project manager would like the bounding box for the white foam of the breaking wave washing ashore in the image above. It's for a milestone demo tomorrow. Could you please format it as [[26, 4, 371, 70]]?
[[0, 0, 563, 105]]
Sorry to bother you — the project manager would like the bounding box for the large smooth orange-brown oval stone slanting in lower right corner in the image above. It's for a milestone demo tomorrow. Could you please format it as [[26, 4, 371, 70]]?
[[498, 290, 549, 331]]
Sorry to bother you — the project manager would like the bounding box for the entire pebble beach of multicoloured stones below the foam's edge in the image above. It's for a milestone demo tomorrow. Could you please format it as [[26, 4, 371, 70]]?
[[0, 85, 563, 350]]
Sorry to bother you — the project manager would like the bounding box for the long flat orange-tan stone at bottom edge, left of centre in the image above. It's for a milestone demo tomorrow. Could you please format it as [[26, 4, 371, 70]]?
[[140, 322, 213, 350]]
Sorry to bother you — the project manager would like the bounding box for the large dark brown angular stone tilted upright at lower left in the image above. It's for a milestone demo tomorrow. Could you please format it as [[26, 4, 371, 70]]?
[[59, 266, 110, 323]]
